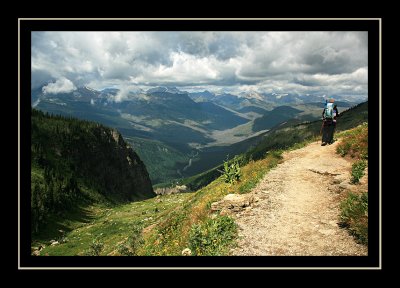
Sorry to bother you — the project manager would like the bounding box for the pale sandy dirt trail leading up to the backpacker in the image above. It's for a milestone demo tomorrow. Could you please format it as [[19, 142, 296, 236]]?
[[232, 142, 368, 255]]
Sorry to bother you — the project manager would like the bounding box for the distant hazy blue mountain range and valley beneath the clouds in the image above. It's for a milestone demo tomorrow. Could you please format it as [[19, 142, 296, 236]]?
[[31, 86, 362, 184]]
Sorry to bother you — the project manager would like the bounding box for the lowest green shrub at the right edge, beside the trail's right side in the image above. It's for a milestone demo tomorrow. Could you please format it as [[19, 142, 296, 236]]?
[[340, 192, 368, 244]]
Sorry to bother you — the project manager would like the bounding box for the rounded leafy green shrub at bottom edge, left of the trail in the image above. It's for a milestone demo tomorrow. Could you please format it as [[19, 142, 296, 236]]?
[[189, 216, 237, 256]]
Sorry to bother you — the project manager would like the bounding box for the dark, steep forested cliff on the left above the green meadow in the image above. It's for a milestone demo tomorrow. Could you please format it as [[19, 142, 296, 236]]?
[[31, 109, 155, 237]]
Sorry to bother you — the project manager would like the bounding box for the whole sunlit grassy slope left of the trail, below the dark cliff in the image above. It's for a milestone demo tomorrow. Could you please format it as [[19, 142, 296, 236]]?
[[36, 153, 279, 256]]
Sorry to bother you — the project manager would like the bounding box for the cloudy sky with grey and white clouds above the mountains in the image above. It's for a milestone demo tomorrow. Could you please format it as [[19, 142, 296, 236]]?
[[32, 32, 368, 97]]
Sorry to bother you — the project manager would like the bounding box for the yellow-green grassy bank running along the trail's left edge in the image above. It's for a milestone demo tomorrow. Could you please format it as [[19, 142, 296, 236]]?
[[143, 152, 282, 255]]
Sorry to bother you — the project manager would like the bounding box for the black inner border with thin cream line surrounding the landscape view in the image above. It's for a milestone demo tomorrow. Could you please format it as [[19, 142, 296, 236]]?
[[18, 18, 382, 269]]
